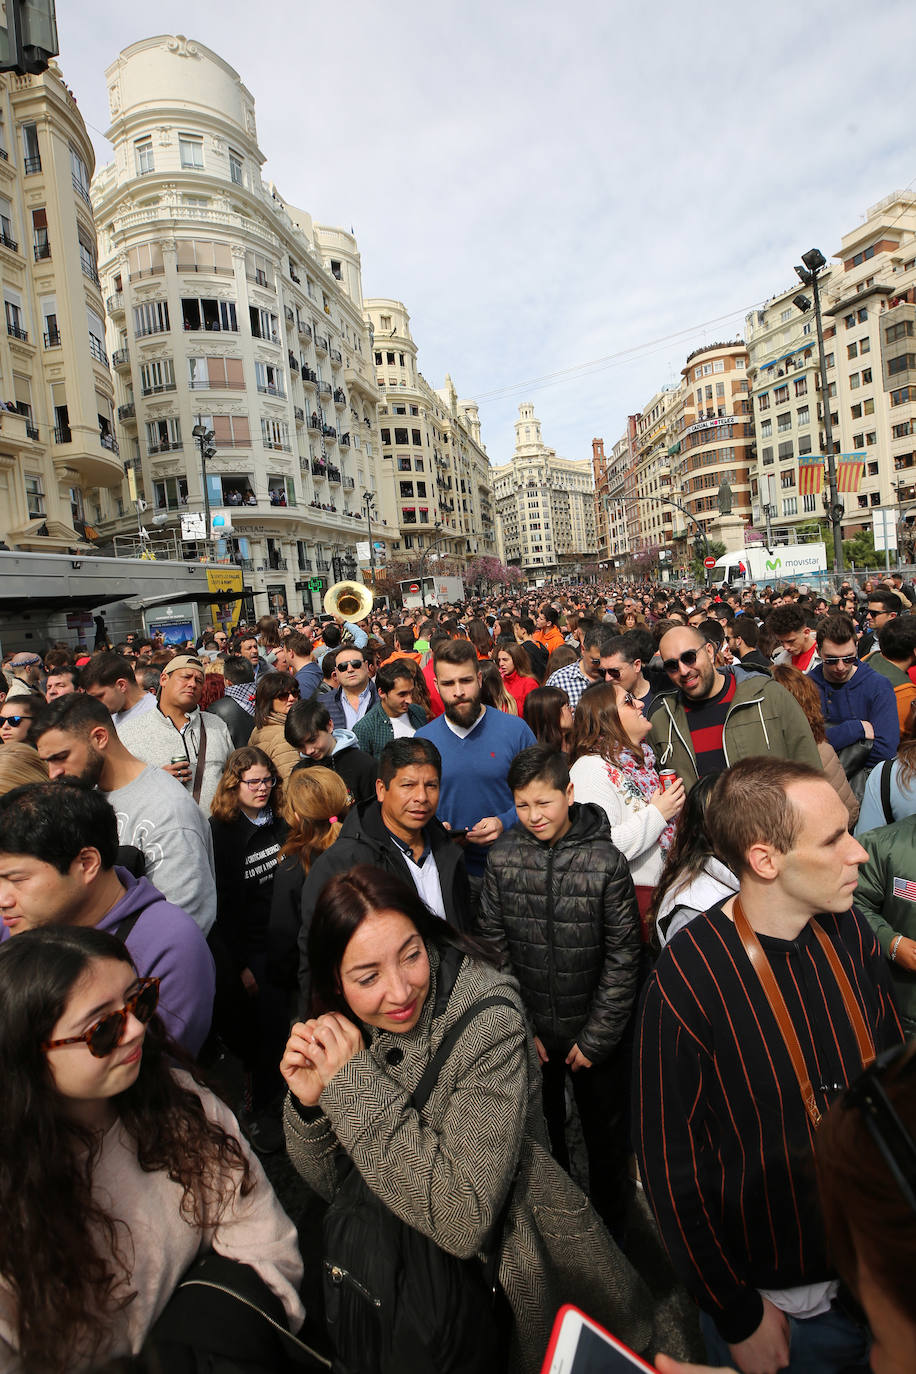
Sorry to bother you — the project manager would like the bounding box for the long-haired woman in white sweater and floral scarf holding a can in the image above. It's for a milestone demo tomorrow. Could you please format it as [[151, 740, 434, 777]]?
[[570, 683, 684, 937]]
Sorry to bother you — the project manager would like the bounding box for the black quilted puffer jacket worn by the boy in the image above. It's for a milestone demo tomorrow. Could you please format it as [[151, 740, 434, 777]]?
[[478, 802, 640, 1063]]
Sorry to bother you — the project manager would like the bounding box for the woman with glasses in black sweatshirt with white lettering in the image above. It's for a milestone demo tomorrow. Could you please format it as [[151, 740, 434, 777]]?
[[210, 747, 290, 1151]]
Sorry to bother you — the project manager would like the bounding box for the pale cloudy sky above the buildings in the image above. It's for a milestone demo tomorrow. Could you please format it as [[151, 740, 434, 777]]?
[[58, 0, 916, 463]]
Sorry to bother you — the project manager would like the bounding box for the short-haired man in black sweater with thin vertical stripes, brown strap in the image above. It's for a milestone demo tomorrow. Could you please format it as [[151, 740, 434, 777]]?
[[633, 757, 902, 1374]]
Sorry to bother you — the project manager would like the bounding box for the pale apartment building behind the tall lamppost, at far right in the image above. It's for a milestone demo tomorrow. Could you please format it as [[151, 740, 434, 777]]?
[[747, 191, 916, 555]]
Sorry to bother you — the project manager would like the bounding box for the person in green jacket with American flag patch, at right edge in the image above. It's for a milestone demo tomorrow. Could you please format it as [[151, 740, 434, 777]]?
[[856, 816, 916, 1039]]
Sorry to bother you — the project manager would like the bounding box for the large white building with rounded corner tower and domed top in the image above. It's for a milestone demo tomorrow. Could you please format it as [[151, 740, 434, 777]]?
[[92, 36, 396, 614]]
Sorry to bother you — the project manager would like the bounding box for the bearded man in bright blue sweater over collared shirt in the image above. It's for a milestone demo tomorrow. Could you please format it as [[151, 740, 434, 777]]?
[[416, 639, 537, 900]]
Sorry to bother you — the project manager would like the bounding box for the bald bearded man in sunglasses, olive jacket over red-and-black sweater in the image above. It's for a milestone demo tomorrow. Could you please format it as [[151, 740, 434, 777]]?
[[648, 625, 821, 791]]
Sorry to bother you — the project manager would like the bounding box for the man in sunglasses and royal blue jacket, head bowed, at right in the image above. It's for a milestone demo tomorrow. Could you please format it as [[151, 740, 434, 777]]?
[[808, 614, 900, 768]]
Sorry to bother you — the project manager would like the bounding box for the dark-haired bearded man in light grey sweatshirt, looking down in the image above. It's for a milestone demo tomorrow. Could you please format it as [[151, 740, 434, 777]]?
[[32, 692, 216, 934]]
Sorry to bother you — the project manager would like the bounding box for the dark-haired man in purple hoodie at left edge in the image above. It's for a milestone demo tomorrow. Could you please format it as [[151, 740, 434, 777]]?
[[0, 779, 214, 1055]]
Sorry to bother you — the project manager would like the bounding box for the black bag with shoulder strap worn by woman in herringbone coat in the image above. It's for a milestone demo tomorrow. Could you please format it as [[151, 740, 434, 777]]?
[[324, 996, 512, 1374]]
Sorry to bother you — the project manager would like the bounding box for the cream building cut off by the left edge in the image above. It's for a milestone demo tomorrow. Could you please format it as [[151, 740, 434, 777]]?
[[0, 62, 124, 552]]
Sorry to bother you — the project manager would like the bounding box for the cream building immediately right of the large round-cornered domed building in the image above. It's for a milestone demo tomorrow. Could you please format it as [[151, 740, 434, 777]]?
[[365, 300, 496, 567]]
